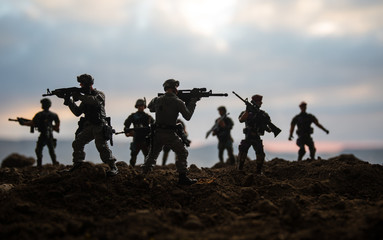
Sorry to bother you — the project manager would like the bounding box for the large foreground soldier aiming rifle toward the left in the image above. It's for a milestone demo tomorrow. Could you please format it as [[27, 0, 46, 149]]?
[[45, 74, 118, 176]]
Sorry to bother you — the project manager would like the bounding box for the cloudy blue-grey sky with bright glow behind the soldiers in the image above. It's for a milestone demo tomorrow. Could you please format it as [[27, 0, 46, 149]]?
[[0, 0, 383, 151]]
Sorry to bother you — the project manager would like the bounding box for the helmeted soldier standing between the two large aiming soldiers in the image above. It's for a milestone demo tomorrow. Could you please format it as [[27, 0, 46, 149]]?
[[124, 98, 154, 167]]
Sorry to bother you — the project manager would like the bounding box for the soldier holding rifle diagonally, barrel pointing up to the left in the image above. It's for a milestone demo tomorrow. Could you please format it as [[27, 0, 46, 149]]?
[[233, 92, 281, 174]]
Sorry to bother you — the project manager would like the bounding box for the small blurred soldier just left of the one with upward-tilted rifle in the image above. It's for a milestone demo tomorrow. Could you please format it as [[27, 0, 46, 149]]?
[[206, 106, 235, 165]]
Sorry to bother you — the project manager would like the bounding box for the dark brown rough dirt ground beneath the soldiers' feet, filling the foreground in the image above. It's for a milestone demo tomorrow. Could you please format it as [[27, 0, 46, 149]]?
[[0, 155, 383, 239]]
